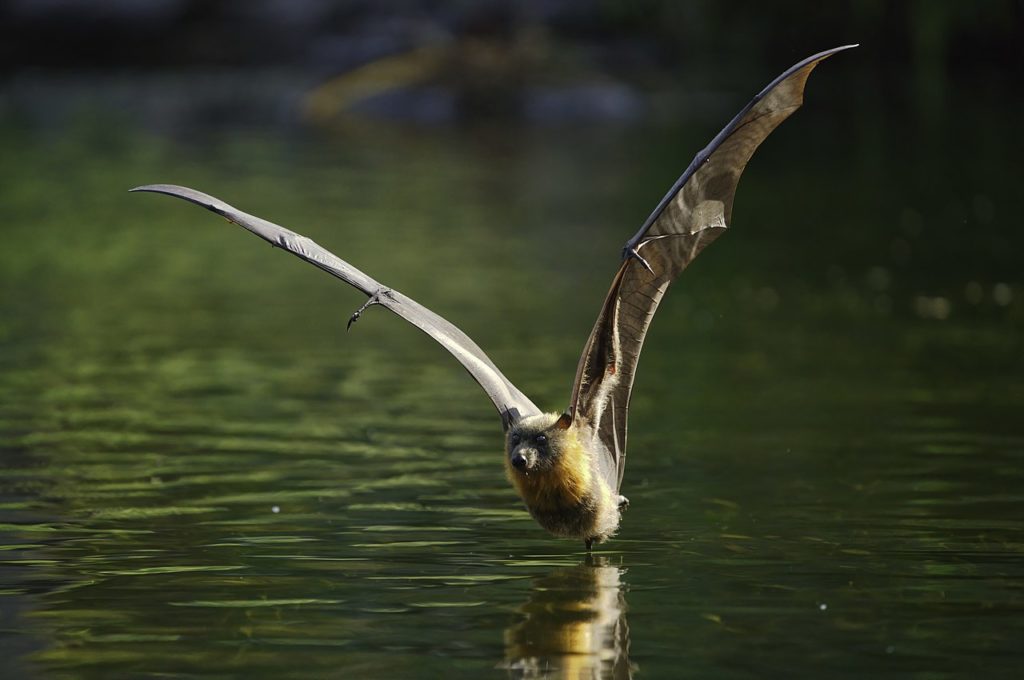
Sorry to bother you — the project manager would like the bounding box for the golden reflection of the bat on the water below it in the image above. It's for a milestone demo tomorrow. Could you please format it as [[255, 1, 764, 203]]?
[[504, 556, 632, 679]]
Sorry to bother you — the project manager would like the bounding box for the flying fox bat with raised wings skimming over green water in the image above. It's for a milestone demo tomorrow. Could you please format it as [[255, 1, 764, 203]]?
[[132, 45, 855, 551]]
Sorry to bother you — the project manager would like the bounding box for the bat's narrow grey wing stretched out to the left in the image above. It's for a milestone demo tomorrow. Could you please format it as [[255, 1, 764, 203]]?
[[131, 184, 541, 429]]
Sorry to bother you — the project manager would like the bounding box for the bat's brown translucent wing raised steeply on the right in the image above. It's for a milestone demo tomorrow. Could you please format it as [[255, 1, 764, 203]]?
[[569, 45, 855, 483]]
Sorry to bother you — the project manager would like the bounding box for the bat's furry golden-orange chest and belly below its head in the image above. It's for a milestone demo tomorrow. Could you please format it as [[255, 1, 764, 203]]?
[[510, 438, 618, 541]]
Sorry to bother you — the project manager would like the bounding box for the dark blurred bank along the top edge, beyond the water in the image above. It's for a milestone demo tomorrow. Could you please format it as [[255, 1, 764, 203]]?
[[0, 0, 1024, 82]]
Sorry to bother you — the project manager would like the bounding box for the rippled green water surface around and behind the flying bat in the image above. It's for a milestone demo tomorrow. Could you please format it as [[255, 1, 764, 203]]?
[[0, 75, 1024, 678]]
